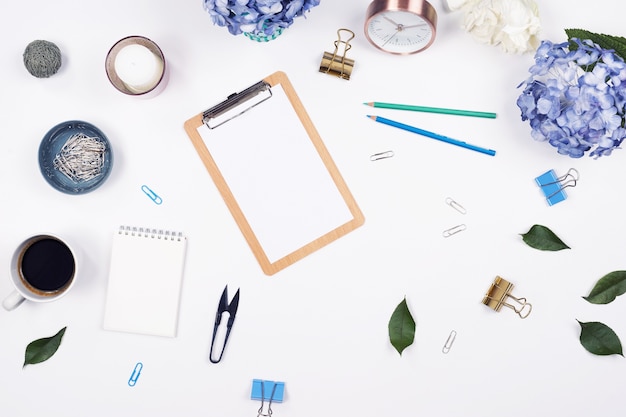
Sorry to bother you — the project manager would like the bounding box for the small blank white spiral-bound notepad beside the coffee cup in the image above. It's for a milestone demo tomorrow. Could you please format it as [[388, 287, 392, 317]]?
[[103, 226, 187, 337]]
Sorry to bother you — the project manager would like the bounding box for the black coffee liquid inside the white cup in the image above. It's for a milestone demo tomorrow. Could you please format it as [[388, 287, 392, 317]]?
[[21, 237, 75, 293]]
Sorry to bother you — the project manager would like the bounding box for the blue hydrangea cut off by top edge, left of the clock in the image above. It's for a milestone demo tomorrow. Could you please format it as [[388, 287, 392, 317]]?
[[203, 0, 320, 36]]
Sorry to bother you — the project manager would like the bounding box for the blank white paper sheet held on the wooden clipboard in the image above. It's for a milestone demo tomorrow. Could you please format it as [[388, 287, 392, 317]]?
[[198, 84, 353, 263]]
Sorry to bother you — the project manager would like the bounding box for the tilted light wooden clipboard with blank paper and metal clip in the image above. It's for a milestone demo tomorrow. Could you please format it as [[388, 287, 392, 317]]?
[[184, 71, 365, 275]]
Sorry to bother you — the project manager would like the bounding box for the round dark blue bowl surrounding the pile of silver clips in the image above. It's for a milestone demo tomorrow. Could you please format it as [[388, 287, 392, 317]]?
[[39, 120, 113, 195]]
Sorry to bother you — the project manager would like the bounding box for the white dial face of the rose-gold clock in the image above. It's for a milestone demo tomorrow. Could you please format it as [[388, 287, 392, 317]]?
[[365, 10, 435, 54]]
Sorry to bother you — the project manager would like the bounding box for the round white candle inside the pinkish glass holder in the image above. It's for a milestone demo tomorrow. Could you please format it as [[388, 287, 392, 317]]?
[[115, 44, 163, 93]]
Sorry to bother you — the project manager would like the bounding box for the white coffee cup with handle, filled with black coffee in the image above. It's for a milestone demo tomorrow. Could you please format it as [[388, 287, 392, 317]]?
[[2, 234, 78, 311]]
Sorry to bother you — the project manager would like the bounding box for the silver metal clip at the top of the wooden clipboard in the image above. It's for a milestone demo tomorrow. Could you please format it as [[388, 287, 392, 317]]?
[[202, 81, 272, 129]]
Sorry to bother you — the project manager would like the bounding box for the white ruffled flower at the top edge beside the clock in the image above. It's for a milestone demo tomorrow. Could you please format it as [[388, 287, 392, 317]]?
[[462, 0, 541, 53]]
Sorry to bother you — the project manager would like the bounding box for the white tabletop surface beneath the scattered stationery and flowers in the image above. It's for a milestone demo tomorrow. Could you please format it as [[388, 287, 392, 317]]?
[[0, 0, 626, 417]]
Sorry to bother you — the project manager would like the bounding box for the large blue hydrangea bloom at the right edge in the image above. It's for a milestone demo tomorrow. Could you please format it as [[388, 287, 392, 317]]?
[[517, 39, 626, 158]]
